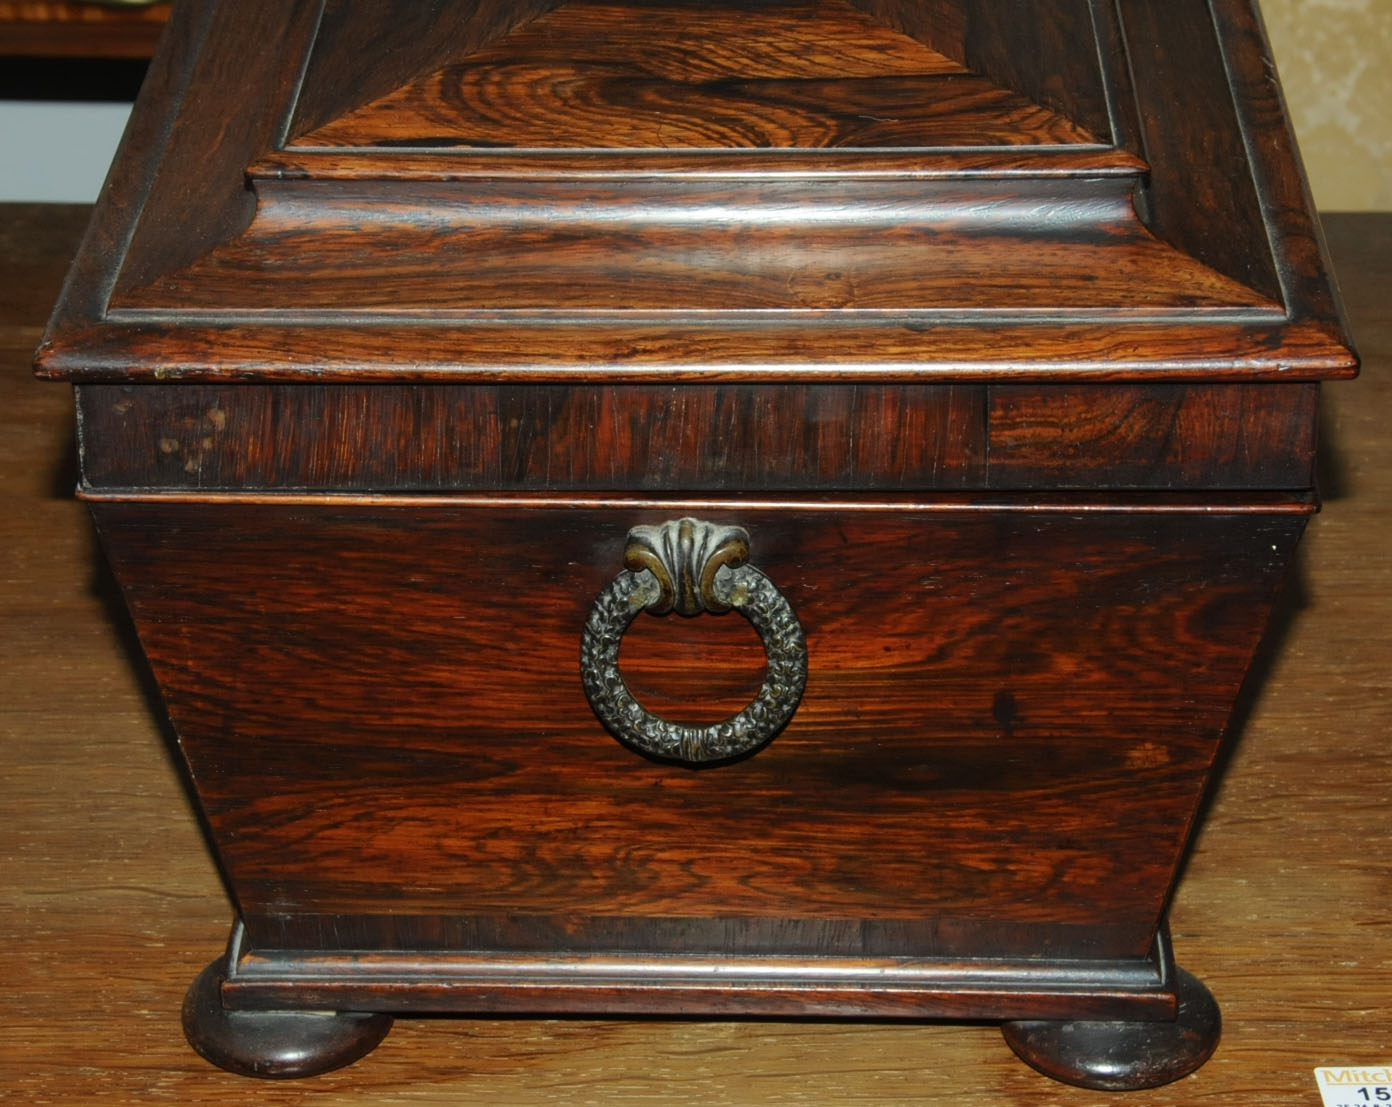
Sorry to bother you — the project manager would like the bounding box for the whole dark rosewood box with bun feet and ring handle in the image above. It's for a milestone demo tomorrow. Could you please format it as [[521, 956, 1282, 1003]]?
[[38, 0, 1356, 1088]]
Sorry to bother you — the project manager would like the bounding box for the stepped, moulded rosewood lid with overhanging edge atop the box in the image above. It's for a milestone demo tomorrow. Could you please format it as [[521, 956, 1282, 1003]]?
[[38, 0, 1356, 382]]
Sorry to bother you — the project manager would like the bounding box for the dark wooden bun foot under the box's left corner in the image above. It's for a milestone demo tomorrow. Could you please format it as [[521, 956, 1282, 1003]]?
[[184, 958, 391, 1078]]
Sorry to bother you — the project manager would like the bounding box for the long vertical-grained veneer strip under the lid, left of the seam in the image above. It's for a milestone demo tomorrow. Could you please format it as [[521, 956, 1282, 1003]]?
[[79, 384, 986, 492]]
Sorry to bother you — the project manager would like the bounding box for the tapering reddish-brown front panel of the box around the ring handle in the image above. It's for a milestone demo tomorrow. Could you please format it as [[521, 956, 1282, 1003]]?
[[95, 503, 1302, 957]]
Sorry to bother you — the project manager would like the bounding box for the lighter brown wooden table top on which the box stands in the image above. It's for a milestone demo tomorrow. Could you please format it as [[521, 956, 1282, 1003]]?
[[0, 205, 1392, 1107]]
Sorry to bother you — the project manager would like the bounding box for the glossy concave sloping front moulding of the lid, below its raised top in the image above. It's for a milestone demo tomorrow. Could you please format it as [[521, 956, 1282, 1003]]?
[[113, 180, 1276, 313]]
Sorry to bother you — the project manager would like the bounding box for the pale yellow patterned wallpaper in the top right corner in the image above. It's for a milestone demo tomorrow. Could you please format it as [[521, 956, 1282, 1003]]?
[[1261, 0, 1392, 212]]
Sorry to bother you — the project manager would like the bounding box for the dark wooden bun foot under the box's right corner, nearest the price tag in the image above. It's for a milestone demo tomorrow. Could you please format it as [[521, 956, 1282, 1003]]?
[[1001, 969, 1222, 1092]]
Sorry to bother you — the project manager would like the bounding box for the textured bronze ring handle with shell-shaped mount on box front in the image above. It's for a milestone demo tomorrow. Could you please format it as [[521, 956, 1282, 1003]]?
[[580, 518, 807, 764]]
